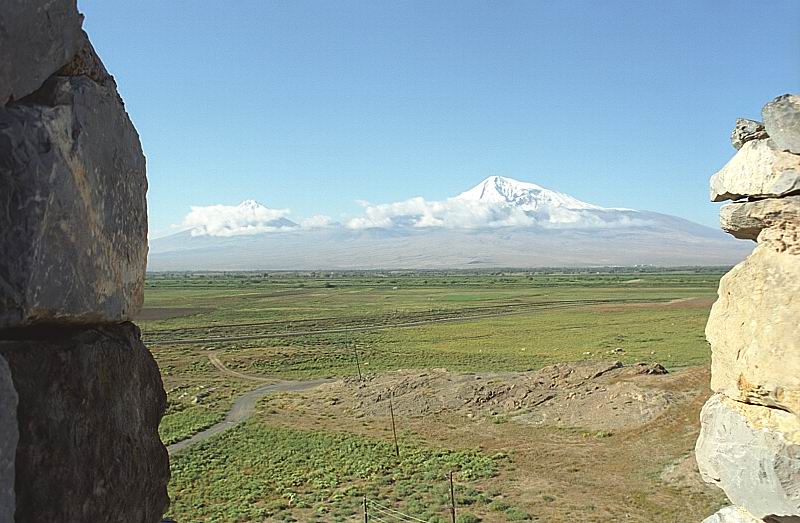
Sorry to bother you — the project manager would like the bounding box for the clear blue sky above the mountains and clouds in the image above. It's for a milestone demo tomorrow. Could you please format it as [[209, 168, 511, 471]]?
[[78, 0, 800, 236]]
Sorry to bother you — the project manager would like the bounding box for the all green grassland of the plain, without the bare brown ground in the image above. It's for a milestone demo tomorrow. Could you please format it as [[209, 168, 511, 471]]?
[[142, 270, 724, 523]]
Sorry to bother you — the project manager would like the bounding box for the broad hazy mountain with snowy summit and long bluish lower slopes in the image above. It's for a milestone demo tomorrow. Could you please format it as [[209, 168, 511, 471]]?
[[148, 177, 752, 271]]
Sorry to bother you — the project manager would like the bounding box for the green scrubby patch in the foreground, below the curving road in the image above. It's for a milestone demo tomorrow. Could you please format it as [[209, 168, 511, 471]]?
[[170, 421, 498, 521]]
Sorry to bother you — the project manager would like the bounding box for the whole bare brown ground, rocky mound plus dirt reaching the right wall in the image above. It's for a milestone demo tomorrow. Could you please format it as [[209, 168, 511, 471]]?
[[257, 362, 724, 523]]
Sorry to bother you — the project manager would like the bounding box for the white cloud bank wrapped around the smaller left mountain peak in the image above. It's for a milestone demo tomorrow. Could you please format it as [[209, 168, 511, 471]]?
[[181, 200, 294, 236]]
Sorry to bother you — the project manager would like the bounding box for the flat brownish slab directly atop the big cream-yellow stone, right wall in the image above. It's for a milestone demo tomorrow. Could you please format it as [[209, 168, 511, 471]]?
[[719, 196, 800, 240]]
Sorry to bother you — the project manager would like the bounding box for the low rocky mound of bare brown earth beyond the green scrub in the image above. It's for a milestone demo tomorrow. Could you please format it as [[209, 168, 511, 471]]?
[[294, 362, 686, 430]]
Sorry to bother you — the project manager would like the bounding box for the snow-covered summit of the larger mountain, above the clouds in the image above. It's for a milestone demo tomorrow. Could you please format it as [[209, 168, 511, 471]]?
[[454, 176, 603, 211]]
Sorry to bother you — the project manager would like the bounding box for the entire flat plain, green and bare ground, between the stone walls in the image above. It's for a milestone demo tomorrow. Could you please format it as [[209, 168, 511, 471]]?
[[138, 270, 724, 523]]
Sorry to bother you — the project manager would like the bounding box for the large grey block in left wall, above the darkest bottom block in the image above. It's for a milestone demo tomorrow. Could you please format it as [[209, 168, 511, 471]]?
[[0, 76, 147, 328]]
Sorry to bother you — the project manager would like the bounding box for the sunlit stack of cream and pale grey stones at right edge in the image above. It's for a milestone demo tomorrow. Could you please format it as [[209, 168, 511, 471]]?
[[696, 95, 800, 523]]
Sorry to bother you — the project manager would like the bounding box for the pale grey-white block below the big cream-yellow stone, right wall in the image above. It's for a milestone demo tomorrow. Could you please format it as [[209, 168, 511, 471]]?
[[695, 394, 800, 518]]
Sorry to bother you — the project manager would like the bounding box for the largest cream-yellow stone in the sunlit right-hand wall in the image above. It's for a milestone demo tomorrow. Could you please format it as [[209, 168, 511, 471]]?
[[706, 239, 800, 414]]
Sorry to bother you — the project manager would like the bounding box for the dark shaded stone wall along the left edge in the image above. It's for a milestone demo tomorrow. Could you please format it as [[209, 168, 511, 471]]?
[[0, 0, 169, 523]]
